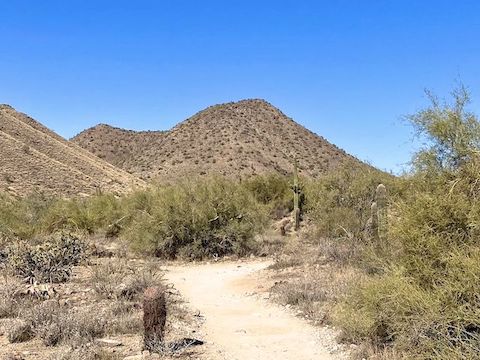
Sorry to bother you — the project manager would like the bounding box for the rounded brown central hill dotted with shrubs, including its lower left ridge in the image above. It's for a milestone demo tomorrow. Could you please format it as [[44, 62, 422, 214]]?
[[72, 100, 359, 180]]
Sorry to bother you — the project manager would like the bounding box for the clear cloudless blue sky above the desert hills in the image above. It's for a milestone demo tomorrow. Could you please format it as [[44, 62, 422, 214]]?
[[0, 0, 480, 171]]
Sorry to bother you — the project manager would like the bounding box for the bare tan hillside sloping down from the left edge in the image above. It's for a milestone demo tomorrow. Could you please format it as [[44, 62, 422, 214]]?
[[0, 105, 143, 195]]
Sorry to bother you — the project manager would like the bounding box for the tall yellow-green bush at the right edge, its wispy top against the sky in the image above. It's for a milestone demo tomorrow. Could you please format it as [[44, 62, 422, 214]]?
[[335, 89, 480, 359]]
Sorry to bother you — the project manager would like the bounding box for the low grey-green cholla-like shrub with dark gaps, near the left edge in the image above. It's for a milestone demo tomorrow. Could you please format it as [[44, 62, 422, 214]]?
[[6, 234, 85, 283]]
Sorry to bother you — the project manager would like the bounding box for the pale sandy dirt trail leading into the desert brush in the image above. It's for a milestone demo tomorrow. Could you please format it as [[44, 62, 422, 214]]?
[[166, 261, 346, 360]]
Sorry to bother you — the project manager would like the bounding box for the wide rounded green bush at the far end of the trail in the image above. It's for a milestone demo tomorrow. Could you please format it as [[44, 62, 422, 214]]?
[[125, 178, 267, 258]]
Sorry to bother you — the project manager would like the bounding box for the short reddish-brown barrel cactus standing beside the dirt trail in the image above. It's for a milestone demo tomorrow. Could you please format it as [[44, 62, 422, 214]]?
[[143, 287, 167, 351]]
